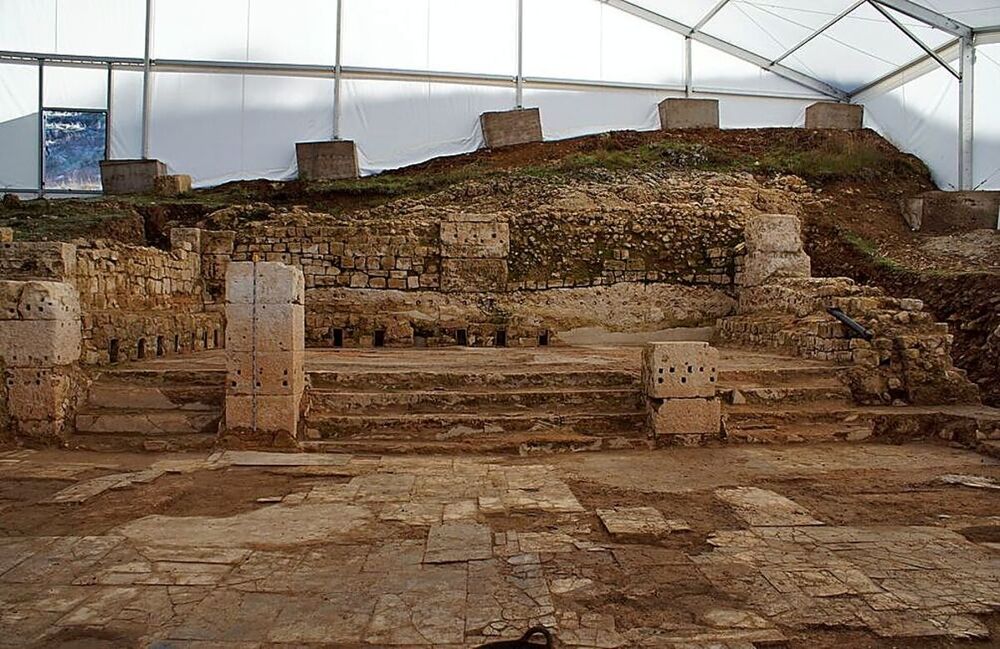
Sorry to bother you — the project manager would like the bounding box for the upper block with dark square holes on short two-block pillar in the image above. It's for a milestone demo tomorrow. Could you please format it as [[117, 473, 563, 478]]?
[[642, 342, 719, 399]]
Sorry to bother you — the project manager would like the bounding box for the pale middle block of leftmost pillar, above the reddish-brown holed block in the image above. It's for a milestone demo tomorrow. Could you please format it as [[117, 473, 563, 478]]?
[[0, 320, 83, 367]]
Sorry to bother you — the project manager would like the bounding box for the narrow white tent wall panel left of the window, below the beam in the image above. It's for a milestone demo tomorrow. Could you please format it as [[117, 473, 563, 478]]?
[[0, 63, 38, 189]]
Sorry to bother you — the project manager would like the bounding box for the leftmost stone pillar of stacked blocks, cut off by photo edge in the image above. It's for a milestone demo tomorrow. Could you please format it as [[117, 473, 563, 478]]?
[[0, 280, 83, 445]]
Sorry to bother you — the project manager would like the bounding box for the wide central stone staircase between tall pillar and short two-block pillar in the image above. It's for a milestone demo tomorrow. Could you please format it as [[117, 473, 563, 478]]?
[[306, 369, 648, 453]]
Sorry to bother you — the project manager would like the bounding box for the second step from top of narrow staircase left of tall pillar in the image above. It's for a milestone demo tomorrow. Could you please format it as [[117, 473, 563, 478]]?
[[84, 381, 225, 411]]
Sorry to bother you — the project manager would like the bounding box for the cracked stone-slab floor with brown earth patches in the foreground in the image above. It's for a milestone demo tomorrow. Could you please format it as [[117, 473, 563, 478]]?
[[0, 444, 1000, 649]]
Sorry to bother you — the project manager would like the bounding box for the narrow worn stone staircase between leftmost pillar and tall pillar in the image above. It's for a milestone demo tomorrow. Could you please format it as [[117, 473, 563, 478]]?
[[70, 370, 225, 451]]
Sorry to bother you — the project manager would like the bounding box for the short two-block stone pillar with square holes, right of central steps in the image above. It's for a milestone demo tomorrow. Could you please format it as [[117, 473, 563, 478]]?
[[642, 342, 722, 446]]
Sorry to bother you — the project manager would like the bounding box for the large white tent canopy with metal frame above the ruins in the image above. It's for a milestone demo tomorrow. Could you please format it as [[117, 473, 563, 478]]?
[[0, 0, 1000, 192]]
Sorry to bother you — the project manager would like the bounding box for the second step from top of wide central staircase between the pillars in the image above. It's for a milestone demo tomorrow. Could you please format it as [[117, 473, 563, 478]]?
[[309, 388, 645, 415]]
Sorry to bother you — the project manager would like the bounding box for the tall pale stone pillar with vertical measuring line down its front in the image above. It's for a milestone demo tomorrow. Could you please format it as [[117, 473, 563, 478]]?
[[224, 262, 305, 448]]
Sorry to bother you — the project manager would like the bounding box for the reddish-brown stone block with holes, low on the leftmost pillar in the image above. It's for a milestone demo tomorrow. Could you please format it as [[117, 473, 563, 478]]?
[[5, 367, 74, 421]]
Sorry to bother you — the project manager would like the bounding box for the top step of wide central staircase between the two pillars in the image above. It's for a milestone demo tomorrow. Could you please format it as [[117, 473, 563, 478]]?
[[308, 370, 640, 392]]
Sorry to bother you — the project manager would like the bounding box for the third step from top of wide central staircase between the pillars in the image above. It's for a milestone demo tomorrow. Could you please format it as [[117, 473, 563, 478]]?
[[307, 411, 647, 442]]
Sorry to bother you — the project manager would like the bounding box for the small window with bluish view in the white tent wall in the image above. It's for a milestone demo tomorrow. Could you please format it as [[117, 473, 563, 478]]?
[[42, 108, 108, 190]]
